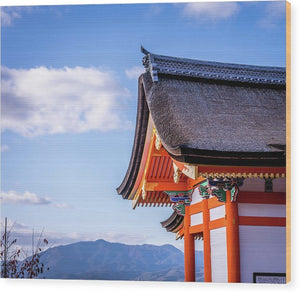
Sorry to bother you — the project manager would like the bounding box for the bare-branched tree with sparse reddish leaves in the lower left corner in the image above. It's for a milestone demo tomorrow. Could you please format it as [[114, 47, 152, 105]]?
[[0, 218, 49, 279]]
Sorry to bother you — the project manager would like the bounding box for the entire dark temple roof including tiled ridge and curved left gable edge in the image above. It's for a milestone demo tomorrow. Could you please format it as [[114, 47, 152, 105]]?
[[117, 48, 286, 198]]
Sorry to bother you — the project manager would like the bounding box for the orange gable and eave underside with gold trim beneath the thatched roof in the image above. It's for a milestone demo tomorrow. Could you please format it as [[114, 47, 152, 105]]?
[[132, 124, 285, 208]]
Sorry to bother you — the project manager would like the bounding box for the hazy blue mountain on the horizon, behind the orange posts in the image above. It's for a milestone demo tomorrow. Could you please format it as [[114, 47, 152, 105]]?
[[40, 239, 203, 281]]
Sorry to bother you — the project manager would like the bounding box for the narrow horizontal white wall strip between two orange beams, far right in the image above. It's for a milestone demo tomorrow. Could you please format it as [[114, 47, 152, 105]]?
[[238, 203, 286, 217]]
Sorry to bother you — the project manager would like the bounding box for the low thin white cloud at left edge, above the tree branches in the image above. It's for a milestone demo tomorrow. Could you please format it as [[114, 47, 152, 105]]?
[[0, 190, 69, 208]]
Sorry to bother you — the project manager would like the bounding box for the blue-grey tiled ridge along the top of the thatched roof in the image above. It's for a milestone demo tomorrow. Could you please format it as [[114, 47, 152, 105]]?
[[141, 47, 286, 86]]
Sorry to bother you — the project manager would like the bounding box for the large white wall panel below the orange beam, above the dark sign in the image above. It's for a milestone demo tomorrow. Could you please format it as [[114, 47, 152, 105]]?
[[239, 226, 286, 283]]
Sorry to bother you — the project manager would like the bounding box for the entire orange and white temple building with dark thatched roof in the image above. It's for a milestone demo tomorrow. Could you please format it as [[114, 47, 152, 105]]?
[[117, 48, 286, 283]]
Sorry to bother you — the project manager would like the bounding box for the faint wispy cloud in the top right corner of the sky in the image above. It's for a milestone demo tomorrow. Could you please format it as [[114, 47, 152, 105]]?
[[259, 1, 286, 29]]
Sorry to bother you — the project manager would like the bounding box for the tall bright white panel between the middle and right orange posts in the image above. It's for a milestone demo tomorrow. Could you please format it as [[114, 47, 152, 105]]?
[[210, 227, 228, 283]]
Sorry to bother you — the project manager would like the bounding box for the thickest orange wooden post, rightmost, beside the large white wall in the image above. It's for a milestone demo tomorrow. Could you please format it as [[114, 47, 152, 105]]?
[[225, 191, 240, 283]]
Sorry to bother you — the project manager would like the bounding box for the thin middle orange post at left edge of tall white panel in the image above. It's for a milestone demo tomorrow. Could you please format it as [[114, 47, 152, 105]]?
[[202, 199, 211, 282]]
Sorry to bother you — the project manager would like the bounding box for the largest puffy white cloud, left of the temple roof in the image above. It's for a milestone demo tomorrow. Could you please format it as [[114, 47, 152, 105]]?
[[2, 67, 132, 136]]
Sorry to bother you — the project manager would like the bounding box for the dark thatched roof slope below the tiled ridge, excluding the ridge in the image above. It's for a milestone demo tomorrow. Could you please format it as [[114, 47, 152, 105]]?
[[143, 73, 286, 165]]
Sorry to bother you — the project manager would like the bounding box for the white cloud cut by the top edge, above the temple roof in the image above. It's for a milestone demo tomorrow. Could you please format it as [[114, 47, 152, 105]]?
[[183, 2, 239, 21]]
